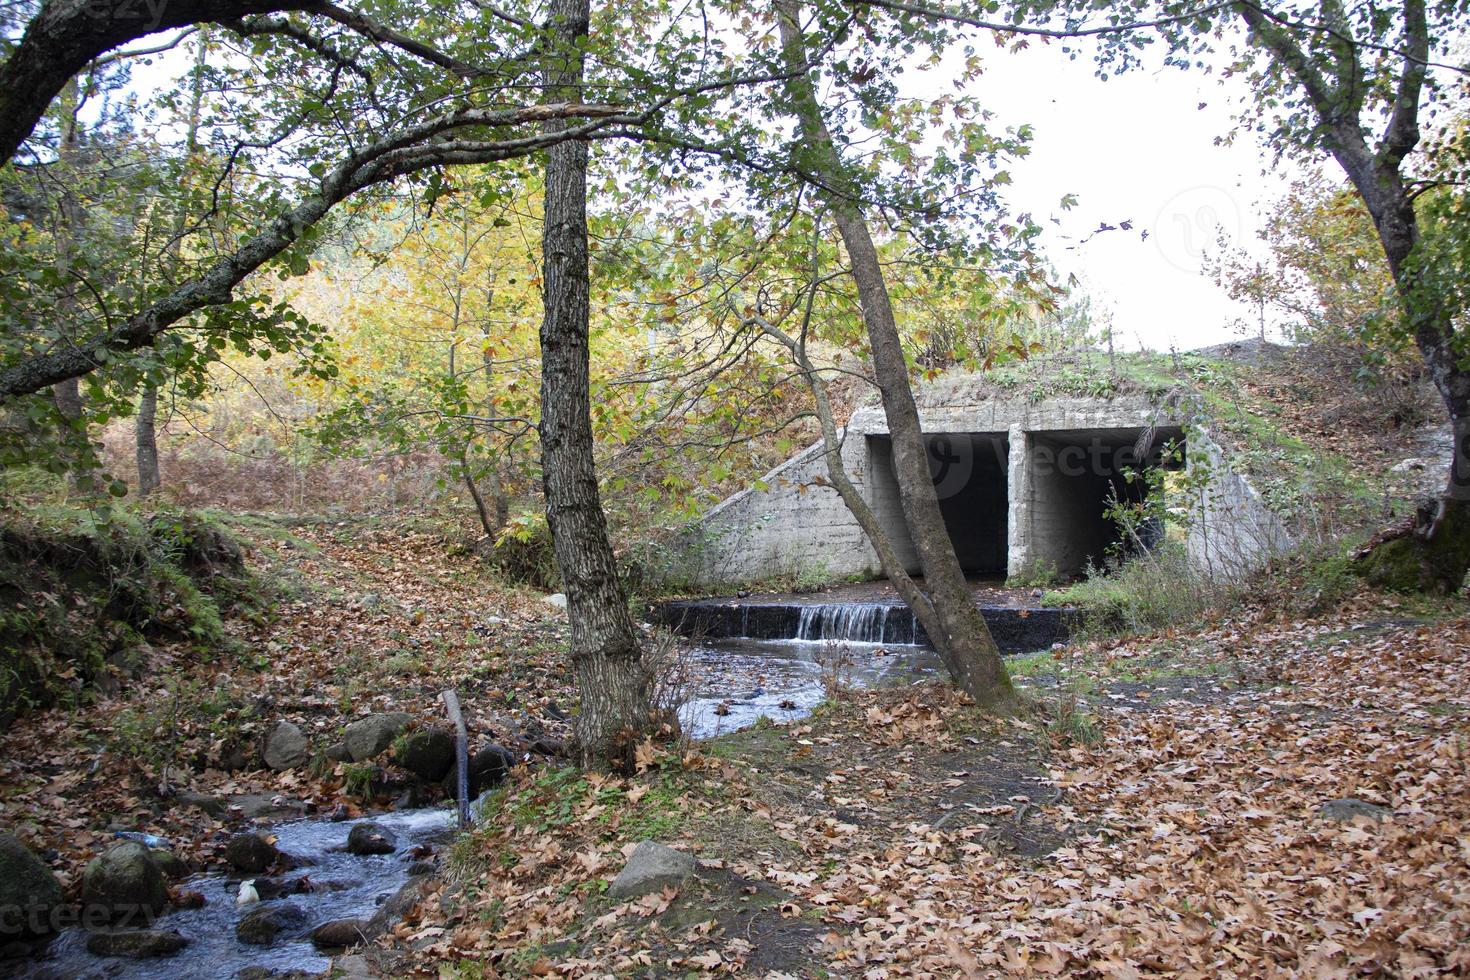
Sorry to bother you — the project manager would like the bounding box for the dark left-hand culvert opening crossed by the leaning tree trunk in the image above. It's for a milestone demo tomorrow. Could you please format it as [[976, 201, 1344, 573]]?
[[867, 432, 1010, 576]]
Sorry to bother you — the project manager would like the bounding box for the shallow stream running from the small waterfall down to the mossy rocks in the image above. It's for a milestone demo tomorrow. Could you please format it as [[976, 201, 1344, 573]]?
[[20, 607, 964, 980]]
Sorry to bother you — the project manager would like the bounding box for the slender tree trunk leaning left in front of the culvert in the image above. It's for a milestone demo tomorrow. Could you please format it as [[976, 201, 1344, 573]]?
[[776, 0, 1014, 707]]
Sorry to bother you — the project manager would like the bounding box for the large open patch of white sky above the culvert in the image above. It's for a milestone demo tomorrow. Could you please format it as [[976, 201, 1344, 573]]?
[[970, 46, 1289, 350]]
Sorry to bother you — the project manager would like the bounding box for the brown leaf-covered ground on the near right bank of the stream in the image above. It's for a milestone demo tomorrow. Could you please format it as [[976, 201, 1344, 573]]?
[[388, 599, 1470, 977]]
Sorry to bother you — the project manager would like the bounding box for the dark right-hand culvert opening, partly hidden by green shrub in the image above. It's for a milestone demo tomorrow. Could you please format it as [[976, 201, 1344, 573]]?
[[1026, 426, 1183, 577]]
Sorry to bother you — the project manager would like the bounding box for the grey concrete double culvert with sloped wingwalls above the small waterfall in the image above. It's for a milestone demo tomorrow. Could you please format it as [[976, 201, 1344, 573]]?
[[675, 383, 1291, 586]]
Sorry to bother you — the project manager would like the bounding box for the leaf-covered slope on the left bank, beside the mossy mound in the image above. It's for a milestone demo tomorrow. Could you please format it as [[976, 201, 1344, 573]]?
[[0, 520, 572, 886]]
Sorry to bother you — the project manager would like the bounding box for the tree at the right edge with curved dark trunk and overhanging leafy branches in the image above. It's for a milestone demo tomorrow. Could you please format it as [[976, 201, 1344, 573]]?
[[863, 0, 1470, 581]]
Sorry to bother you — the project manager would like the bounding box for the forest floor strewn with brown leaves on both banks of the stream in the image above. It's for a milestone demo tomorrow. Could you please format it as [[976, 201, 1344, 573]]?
[[0, 522, 1470, 977]]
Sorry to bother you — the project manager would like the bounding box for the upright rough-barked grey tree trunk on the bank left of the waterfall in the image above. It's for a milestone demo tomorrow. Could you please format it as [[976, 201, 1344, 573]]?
[[541, 0, 651, 770]]
